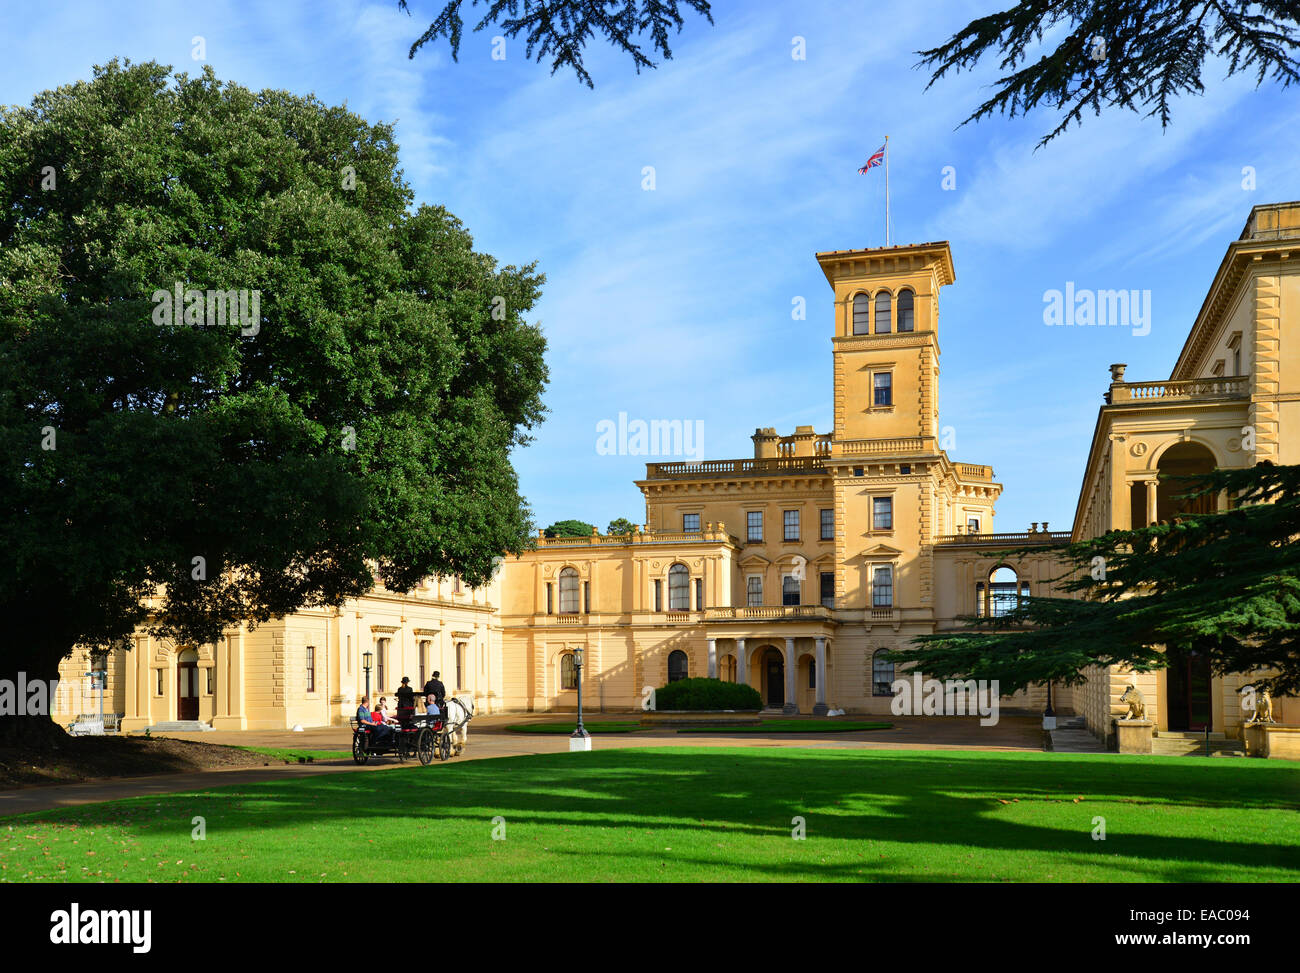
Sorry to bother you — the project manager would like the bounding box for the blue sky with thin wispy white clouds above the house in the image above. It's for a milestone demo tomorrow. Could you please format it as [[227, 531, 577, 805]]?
[[0, 0, 1300, 531]]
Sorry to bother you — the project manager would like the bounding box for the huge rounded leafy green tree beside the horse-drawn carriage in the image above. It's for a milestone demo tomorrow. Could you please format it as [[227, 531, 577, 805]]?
[[0, 61, 546, 736]]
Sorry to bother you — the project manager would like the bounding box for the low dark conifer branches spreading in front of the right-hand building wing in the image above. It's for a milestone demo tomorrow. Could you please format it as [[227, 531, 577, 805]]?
[[893, 463, 1300, 693]]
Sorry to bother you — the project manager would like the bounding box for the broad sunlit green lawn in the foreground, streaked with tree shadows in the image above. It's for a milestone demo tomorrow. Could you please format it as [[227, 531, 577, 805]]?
[[0, 747, 1300, 882]]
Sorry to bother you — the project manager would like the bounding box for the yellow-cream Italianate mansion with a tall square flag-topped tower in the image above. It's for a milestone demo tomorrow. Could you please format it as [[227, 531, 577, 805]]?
[[56, 203, 1300, 740]]
